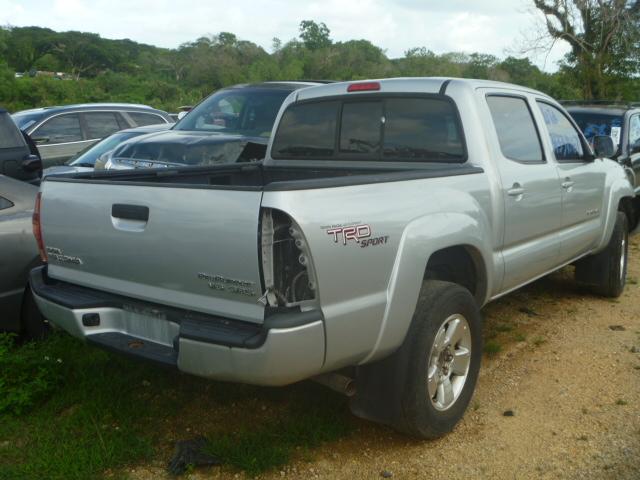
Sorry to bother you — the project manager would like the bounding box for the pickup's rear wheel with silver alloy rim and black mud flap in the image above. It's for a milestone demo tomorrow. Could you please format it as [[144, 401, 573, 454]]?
[[352, 280, 482, 438]]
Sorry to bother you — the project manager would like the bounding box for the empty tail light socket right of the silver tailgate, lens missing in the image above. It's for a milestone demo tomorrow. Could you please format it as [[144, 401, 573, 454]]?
[[260, 208, 317, 308]]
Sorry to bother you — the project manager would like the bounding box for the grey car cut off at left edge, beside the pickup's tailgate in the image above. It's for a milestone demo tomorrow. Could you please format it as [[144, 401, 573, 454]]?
[[0, 175, 47, 338]]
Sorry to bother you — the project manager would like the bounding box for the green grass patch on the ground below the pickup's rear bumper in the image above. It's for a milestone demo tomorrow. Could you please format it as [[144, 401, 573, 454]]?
[[0, 334, 353, 480]]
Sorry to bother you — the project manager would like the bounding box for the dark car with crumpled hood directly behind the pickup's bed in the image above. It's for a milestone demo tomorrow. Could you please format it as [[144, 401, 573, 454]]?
[[107, 81, 328, 169]]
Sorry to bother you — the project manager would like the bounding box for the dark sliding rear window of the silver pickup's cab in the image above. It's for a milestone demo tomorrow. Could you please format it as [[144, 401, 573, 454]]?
[[271, 94, 467, 163]]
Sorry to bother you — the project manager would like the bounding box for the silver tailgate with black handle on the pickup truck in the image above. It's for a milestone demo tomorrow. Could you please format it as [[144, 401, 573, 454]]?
[[41, 181, 264, 323]]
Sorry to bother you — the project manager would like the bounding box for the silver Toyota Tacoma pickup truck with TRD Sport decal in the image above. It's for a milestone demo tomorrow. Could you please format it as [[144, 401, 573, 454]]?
[[31, 78, 634, 438]]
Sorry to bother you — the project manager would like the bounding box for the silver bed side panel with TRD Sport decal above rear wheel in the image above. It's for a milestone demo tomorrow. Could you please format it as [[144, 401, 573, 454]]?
[[263, 173, 501, 370]]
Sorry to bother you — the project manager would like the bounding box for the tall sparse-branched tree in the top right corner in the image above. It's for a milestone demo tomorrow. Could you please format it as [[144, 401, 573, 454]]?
[[533, 0, 640, 99]]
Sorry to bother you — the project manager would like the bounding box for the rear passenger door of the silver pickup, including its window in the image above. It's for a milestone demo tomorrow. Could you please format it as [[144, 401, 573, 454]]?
[[485, 91, 561, 292]]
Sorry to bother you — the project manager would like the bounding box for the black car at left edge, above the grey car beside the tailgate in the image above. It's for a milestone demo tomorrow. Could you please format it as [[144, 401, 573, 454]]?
[[0, 107, 42, 183]]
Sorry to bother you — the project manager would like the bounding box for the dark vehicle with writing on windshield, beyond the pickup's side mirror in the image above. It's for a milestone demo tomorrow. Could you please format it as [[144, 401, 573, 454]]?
[[563, 101, 640, 227]]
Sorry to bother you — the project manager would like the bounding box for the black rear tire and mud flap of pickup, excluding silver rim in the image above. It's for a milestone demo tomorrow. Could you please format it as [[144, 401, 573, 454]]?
[[351, 280, 482, 439]]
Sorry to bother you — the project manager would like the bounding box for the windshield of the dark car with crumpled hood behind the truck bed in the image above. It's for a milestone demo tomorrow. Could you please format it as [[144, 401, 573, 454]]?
[[173, 88, 291, 138]]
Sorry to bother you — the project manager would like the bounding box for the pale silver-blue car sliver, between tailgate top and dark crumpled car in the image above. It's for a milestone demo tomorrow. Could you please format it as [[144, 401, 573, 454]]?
[[44, 123, 171, 176]]
